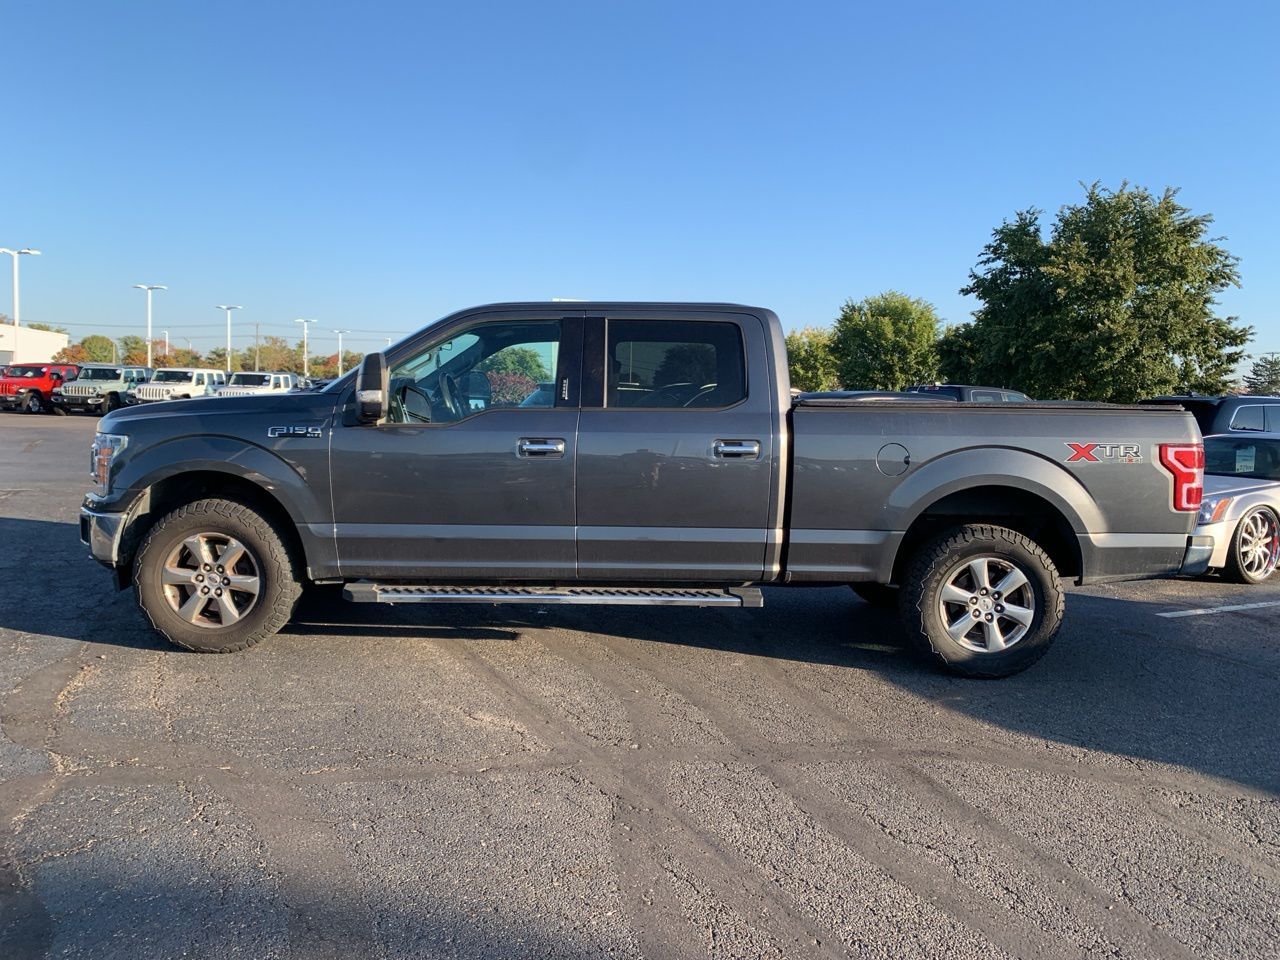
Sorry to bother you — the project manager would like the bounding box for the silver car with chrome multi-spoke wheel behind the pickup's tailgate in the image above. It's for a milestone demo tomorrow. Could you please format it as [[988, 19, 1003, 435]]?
[[1196, 433, 1280, 584]]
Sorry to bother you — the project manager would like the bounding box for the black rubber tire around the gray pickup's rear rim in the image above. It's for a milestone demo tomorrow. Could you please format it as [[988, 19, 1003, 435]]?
[[901, 524, 1065, 677]]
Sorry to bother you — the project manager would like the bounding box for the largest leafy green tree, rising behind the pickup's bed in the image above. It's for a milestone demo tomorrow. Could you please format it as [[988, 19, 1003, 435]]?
[[961, 183, 1253, 402]]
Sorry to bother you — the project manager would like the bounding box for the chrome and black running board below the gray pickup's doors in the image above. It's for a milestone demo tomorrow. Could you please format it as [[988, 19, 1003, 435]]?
[[342, 580, 764, 607]]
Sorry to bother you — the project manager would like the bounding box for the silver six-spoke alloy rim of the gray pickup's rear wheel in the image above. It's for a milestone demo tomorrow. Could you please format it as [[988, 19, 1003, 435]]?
[[938, 557, 1036, 653]]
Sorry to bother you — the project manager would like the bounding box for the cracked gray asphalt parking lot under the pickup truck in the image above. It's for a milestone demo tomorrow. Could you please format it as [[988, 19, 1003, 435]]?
[[0, 415, 1280, 960]]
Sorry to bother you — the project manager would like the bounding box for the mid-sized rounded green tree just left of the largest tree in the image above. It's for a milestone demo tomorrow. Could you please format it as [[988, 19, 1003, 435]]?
[[833, 291, 938, 390]]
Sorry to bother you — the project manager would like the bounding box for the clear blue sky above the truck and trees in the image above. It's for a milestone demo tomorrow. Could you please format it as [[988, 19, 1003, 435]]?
[[0, 0, 1280, 352]]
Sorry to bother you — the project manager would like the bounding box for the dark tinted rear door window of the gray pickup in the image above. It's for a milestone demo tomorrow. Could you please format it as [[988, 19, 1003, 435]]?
[[605, 320, 746, 410]]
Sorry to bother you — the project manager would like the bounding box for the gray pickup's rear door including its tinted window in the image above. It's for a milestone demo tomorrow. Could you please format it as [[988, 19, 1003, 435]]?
[[577, 311, 781, 581]]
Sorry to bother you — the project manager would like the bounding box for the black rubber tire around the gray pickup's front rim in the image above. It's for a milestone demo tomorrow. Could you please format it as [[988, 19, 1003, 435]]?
[[133, 499, 302, 653]]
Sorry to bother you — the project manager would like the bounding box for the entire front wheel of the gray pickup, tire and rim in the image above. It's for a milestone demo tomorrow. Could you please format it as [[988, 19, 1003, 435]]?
[[133, 499, 302, 653]]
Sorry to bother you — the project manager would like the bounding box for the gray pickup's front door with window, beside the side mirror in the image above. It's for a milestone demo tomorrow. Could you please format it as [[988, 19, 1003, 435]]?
[[330, 316, 582, 581]]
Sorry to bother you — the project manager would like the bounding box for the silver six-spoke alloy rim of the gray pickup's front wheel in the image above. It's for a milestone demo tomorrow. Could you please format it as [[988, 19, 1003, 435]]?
[[160, 534, 262, 627]]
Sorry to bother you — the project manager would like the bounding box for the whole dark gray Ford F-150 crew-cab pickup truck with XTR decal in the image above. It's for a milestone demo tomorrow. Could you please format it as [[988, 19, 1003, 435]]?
[[81, 303, 1212, 676]]
